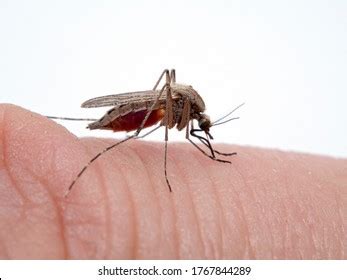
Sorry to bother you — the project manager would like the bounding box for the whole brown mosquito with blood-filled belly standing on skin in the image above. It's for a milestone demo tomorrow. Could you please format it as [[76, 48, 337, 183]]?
[[47, 69, 244, 197]]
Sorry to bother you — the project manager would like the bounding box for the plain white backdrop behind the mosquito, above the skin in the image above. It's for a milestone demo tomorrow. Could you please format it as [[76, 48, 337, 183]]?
[[0, 0, 347, 157]]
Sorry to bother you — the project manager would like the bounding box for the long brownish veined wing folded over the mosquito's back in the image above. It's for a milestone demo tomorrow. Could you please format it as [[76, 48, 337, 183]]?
[[81, 90, 170, 108]]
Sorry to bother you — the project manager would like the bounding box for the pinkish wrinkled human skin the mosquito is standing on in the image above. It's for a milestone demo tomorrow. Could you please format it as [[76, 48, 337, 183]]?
[[0, 105, 347, 259]]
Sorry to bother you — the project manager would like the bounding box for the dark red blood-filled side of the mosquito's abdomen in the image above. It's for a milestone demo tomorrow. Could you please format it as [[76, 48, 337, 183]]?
[[105, 109, 165, 132]]
